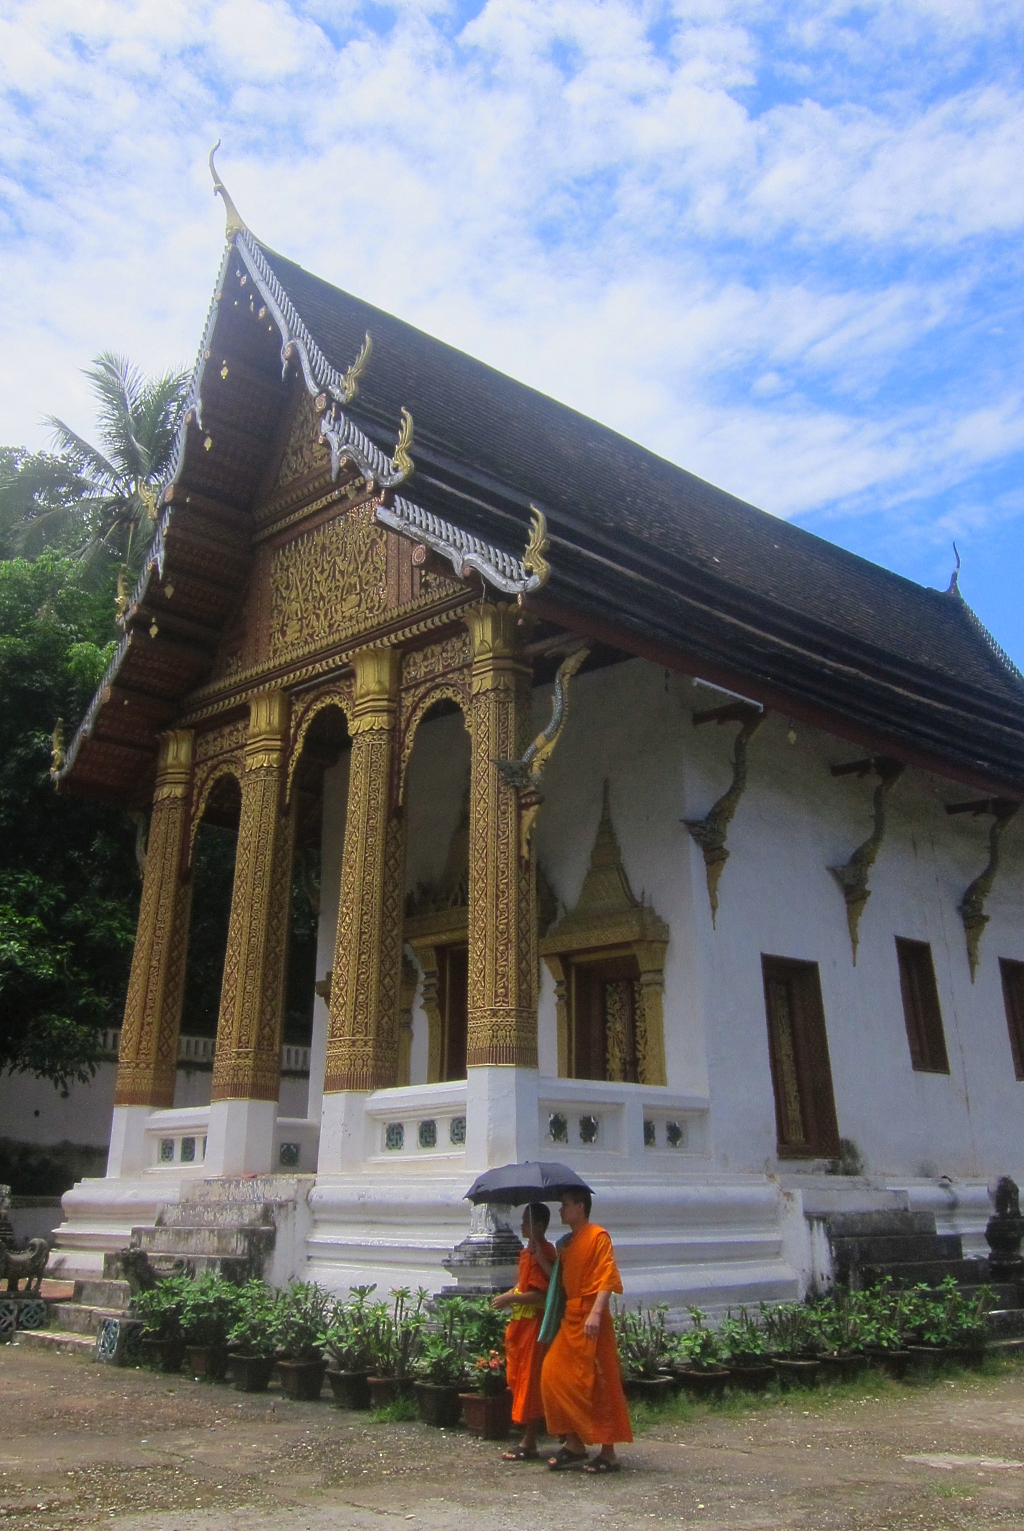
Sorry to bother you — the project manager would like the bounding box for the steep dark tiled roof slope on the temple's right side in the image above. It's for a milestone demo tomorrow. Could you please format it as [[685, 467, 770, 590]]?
[[260, 246, 1024, 787]]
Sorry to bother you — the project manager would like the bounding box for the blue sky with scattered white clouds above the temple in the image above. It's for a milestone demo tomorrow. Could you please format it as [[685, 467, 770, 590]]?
[[0, 0, 1024, 666]]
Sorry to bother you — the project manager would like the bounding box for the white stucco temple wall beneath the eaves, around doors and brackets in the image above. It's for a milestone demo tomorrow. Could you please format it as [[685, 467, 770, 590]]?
[[526, 660, 1024, 1176]]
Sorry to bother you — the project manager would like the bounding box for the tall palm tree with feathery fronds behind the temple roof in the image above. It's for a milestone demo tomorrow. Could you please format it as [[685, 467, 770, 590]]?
[[0, 351, 188, 573]]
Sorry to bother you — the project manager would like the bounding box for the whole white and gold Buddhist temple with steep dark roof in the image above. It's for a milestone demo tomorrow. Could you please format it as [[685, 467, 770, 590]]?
[[52, 176, 1024, 1307]]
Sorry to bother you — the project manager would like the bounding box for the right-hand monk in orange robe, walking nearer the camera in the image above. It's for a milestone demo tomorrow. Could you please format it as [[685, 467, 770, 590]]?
[[540, 1190, 632, 1473]]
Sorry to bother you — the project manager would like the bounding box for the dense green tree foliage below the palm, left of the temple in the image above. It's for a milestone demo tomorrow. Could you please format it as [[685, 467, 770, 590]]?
[[0, 553, 139, 1087]]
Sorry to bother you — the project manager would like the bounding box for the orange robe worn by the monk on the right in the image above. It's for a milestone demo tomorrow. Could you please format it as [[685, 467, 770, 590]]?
[[540, 1223, 632, 1445]]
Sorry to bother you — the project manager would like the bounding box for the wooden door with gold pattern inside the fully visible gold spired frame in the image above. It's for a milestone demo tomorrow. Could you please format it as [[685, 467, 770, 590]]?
[[569, 957, 640, 1082]]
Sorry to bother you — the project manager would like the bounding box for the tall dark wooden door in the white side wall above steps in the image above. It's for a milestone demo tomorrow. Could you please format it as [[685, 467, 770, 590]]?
[[761, 957, 839, 1159]]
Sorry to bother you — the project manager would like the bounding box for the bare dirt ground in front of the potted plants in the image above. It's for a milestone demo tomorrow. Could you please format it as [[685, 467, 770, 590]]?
[[0, 1346, 1024, 1531]]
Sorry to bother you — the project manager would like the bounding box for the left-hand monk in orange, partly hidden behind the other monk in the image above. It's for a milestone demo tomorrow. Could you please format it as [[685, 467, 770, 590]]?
[[493, 1202, 556, 1462]]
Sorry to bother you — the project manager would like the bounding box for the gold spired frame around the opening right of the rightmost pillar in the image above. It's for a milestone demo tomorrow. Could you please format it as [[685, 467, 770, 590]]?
[[540, 782, 669, 1084]]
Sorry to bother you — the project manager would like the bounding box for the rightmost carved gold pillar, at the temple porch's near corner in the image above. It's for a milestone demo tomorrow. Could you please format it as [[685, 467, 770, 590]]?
[[465, 605, 537, 1069]]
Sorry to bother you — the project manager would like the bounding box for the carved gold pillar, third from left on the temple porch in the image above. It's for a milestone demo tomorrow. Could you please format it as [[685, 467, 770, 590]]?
[[323, 649, 406, 1095]]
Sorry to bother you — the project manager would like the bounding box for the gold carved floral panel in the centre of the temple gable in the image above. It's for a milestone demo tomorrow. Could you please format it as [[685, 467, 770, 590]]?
[[269, 505, 387, 660]]
